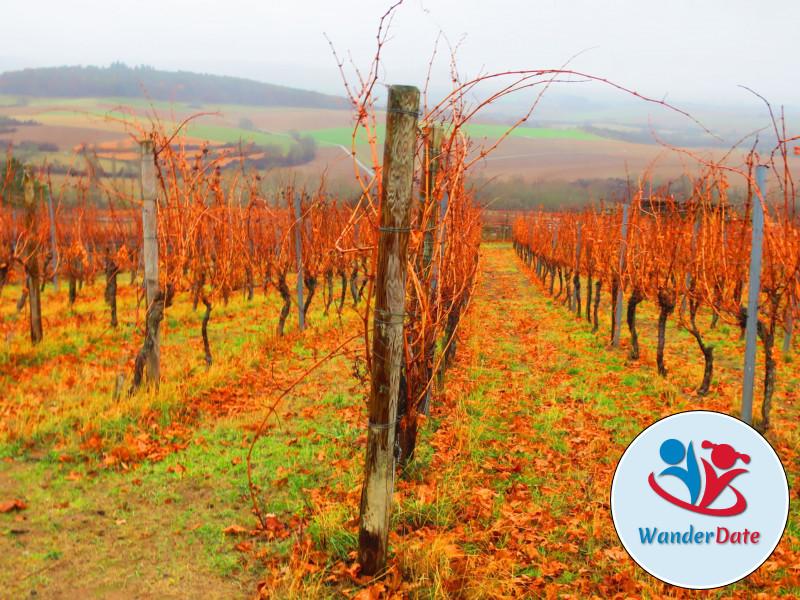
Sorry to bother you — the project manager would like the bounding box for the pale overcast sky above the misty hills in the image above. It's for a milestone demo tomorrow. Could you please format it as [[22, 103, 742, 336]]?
[[0, 0, 800, 105]]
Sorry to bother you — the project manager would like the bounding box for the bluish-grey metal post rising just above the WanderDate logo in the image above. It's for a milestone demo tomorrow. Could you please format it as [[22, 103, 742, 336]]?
[[742, 165, 767, 425]]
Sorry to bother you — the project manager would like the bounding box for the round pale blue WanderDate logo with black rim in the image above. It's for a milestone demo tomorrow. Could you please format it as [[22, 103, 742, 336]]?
[[611, 410, 789, 589]]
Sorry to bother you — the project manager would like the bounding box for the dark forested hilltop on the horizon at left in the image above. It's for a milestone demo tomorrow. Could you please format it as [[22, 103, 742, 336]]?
[[0, 62, 350, 109]]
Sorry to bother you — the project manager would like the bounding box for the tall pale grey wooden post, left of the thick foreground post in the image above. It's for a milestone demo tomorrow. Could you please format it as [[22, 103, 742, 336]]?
[[139, 140, 161, 386]]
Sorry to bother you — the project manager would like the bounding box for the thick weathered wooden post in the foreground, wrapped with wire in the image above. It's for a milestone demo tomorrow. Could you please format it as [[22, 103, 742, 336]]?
[[358, 86, 419, 575]]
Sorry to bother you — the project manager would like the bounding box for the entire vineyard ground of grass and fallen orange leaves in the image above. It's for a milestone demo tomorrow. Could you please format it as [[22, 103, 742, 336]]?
[[0, 245, 800, 600]]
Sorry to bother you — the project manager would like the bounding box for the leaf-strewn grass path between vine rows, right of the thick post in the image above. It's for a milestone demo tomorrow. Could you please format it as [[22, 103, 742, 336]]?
[[390, 246, 674, 597]]
